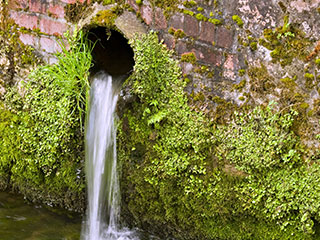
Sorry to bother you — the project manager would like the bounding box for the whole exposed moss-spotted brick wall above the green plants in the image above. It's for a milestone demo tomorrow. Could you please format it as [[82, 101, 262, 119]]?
[[6, 0, 320, 147]]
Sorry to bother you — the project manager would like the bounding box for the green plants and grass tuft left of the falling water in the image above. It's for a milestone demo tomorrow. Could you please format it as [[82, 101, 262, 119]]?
[[0, 32, 91, 211]]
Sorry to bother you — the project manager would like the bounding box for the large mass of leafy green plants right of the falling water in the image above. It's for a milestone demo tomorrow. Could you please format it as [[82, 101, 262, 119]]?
[[118, 33, 320, 239]]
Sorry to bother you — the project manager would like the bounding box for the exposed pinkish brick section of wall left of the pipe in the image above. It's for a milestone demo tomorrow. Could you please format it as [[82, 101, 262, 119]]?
[[9, 0, 83, 62]]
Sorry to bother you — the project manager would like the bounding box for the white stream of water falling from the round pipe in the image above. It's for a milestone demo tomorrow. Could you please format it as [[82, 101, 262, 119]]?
[[82, 72, 137, 240]]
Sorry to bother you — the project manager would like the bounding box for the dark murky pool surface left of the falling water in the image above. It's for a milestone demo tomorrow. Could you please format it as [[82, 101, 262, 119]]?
[[0, 192, 82, 240]]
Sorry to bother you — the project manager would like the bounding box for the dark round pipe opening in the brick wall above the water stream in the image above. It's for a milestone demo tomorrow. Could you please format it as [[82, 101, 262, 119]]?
[[88, 27, 134, 76]]
